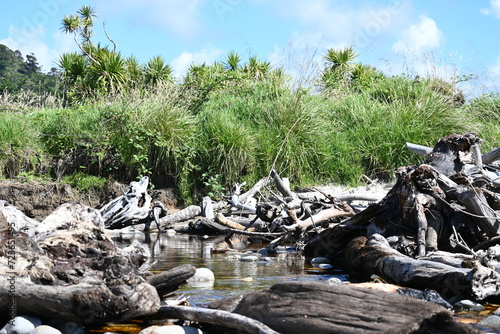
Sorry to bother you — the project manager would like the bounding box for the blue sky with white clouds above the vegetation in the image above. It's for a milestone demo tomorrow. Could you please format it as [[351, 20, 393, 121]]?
[[0, 0, 500, 97]]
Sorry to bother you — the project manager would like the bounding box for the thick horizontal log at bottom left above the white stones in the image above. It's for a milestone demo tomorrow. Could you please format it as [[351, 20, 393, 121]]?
[[0, 276, 160, 324]]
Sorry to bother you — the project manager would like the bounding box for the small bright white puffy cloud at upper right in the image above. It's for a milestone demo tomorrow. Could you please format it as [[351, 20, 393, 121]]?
[[392, 15, 443, 54]]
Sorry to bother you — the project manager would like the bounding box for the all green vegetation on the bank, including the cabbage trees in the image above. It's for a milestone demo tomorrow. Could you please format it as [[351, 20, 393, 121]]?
[[0, 8, 500, 201]]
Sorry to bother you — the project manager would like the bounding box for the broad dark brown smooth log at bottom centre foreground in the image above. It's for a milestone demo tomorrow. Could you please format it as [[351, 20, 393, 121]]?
[[206, 282, 477, 334]]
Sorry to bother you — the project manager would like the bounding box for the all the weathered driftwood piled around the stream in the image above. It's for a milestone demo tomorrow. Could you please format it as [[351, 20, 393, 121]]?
[[0, 134, 500, 333]]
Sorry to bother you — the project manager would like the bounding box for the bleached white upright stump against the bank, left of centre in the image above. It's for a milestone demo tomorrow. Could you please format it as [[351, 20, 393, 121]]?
[[100, 176, 152, 229]]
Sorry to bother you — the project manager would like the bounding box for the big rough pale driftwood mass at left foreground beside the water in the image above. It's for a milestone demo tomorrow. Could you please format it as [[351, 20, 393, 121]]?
[[0, 203, 195, 324]]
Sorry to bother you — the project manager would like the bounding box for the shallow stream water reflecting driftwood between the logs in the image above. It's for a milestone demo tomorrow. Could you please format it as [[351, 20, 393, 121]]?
[[113, 232, 347, 306]]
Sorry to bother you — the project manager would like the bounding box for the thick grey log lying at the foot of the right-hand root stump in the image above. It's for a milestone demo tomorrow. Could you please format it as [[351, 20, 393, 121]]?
[[346, 234, 500, 301]]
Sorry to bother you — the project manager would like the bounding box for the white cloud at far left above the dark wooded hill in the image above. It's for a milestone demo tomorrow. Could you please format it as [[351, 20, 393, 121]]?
[[0, 25, 74, 72]]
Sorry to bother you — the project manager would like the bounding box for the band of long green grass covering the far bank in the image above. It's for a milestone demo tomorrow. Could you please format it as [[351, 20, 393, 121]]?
[[0, 68, 500, 202]]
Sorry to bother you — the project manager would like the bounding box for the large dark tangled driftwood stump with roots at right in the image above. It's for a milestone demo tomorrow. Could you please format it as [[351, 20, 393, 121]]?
[[304, 134, 500, 300]]
